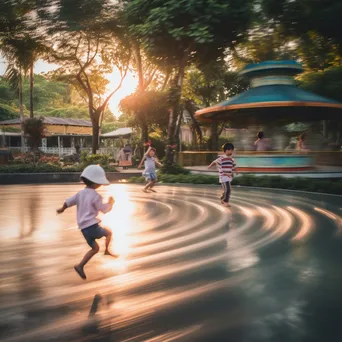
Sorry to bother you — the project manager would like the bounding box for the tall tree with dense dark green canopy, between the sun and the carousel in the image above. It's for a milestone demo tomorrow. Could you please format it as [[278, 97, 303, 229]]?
[[126, 0, 251, 164]]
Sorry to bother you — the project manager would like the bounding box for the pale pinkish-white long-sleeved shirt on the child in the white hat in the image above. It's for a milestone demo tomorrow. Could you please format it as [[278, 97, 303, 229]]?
[[65, 188, 111, 229]]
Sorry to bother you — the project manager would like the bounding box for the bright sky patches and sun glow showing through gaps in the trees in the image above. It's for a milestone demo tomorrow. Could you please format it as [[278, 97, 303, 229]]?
[[0, 57, 138, 117]]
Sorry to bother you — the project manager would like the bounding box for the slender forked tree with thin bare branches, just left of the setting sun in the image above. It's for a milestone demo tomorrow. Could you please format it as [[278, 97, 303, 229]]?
[[51, 0, 130, 154]]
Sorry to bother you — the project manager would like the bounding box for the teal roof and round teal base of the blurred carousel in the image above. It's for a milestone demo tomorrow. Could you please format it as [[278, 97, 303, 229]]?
[[195, 61, 342, 172]]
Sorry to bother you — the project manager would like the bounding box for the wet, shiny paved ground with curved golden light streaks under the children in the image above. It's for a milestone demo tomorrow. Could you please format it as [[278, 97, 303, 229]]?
[[0, 185, 342, 342]]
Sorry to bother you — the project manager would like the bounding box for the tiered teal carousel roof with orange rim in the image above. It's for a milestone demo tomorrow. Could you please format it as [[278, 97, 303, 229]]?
[[196, 61, 342, 123]]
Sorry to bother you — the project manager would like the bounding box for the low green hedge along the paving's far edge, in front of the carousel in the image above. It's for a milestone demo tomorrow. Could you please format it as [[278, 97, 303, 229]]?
[[129, 174, 342, 195]]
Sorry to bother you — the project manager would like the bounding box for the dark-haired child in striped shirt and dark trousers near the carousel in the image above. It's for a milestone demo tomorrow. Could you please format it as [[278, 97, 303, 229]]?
[[208, 143, 239, 207]]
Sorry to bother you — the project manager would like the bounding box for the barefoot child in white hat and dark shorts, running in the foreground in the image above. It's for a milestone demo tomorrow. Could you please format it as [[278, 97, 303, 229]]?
[[57, 165, 118, 279]]
